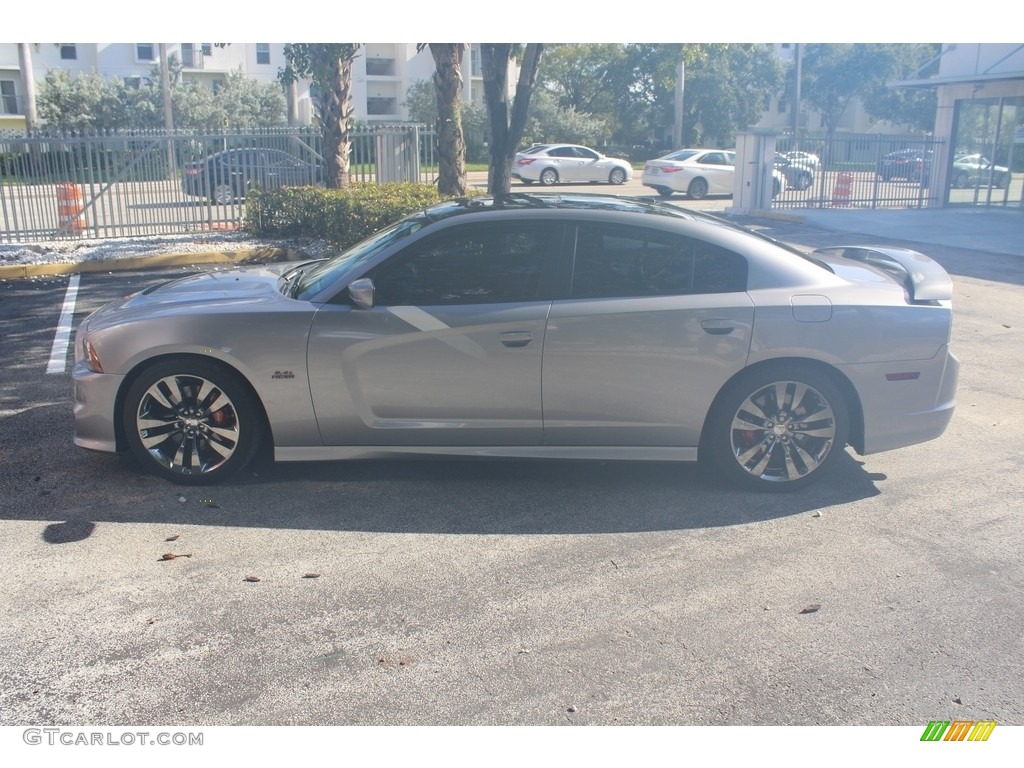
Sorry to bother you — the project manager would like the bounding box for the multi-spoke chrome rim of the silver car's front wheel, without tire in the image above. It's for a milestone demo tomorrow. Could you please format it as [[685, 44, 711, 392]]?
[[135, 375, 240, 475]]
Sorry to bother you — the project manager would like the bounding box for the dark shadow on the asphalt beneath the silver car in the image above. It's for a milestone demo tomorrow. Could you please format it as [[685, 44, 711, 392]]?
[[0, 406, 885, 543]]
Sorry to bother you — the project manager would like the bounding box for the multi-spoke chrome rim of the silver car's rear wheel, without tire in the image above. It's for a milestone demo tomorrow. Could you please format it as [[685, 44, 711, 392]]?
[[729, 381, 838, 482]]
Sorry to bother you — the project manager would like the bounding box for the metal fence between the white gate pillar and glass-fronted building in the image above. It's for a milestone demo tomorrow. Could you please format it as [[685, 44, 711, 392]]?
[[772, 135, 943, 208]]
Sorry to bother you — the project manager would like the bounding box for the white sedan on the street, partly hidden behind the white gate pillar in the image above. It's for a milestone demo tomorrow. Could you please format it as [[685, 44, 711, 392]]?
[[641, 150, 785, 200]]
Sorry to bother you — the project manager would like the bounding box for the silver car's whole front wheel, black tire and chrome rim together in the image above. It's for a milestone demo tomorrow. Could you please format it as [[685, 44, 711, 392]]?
[[123, 357, 264, 485]]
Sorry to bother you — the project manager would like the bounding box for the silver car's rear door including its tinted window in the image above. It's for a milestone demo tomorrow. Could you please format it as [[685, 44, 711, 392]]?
[[544, 223, 754, 446]]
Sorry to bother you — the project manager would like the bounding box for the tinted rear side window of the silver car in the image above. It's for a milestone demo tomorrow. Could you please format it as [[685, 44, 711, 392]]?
[[569, 224, 746, 299]]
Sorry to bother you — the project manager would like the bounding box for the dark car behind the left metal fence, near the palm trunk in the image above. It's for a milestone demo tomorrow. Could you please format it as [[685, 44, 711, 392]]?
[[181, 148, 324, 205]]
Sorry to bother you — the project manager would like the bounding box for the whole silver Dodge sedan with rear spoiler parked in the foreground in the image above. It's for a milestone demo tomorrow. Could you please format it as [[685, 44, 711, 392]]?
[[74, 195, 958, 490]]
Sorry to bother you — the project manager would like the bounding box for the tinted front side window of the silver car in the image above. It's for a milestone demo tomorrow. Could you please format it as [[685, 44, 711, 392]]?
[[370, 221, 563, 306]]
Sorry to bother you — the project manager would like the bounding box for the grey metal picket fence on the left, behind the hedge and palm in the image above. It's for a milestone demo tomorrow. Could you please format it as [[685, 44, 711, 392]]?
[[0, 124, 437, 243]]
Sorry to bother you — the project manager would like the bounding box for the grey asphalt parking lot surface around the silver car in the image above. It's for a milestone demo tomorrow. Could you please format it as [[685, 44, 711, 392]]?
[[0, 214, 1024, 727]]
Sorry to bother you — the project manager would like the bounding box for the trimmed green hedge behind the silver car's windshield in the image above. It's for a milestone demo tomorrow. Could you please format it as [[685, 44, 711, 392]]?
[[245, 183, 442, 248]]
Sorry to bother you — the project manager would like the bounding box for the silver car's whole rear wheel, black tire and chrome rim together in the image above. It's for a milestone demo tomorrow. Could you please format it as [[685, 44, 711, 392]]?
[[705, 365, 850, 492]]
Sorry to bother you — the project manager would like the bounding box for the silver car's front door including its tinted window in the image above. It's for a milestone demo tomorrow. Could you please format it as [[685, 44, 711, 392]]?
[[308, 222, 564, 445]]
